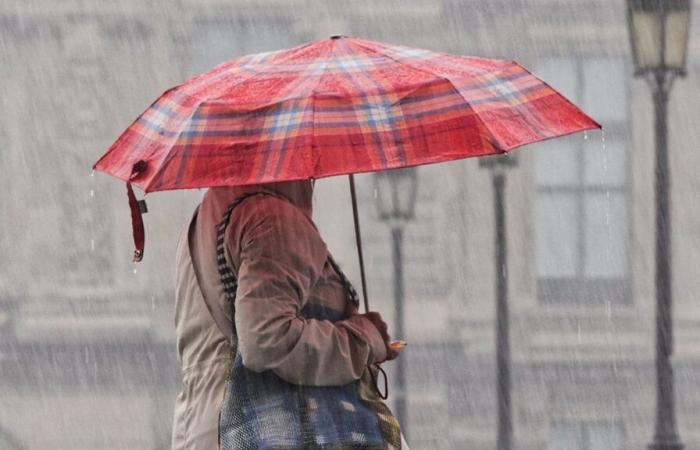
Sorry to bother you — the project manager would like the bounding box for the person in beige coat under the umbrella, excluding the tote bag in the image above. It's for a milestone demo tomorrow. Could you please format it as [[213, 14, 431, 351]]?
[[172, 180, 407, 449]]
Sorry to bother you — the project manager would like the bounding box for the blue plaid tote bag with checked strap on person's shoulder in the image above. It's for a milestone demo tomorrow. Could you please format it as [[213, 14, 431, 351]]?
[[217, 193, 401, 450]]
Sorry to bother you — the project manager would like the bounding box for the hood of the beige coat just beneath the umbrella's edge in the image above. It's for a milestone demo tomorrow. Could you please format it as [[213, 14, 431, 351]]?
[[204, 180, 313, 218]]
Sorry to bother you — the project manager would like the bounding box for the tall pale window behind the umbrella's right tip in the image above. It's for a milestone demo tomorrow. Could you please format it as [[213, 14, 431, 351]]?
[[534, 59, 631, 304]]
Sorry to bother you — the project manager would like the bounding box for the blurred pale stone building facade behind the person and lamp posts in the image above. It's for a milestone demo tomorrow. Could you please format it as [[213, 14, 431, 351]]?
[[0, 0, 700, 450]]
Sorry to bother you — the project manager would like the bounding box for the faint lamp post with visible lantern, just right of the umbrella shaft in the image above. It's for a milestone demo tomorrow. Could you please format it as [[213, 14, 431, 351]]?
[[374, 167, 418, 432]]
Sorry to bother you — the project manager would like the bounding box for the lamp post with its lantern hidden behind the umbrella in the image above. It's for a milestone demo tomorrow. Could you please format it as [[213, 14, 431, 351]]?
[[479, 155, 517, 450]]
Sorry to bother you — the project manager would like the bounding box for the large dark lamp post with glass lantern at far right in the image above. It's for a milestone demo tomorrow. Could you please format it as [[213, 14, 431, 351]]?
[[627, 0, 690, 450]]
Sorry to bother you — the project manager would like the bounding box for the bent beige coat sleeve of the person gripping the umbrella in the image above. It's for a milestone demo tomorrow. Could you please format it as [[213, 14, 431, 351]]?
[[231, 197, 386, 386]]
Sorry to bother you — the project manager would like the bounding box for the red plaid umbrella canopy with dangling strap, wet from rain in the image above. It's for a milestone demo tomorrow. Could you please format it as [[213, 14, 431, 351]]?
[[93, 36, 600, 274]]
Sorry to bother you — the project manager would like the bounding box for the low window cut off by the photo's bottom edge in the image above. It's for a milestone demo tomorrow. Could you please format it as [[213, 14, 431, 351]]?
[[547, 422, 624, 450]]
